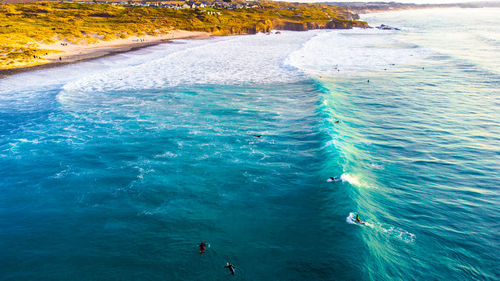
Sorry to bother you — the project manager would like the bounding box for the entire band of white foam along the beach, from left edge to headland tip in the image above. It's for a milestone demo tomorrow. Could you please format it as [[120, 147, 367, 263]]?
[[0, 29, 430, 108]]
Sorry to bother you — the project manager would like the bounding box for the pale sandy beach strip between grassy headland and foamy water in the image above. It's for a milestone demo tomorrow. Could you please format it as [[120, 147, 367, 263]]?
[[0, 30, 211, 79]]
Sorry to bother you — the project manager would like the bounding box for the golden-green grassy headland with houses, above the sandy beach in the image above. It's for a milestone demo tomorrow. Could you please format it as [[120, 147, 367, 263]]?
[[0, 2, 366, 69]]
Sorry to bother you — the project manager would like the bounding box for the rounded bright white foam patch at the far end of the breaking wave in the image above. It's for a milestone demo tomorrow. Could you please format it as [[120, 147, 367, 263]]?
[[286, 29, 428, 77]]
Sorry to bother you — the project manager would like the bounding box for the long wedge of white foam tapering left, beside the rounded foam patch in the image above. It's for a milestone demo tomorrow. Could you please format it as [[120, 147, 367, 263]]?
[[59, 32, 315, 96]]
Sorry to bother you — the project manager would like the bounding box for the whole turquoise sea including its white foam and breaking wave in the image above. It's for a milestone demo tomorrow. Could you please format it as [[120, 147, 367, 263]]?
[[0, 9, 500, 280]]
